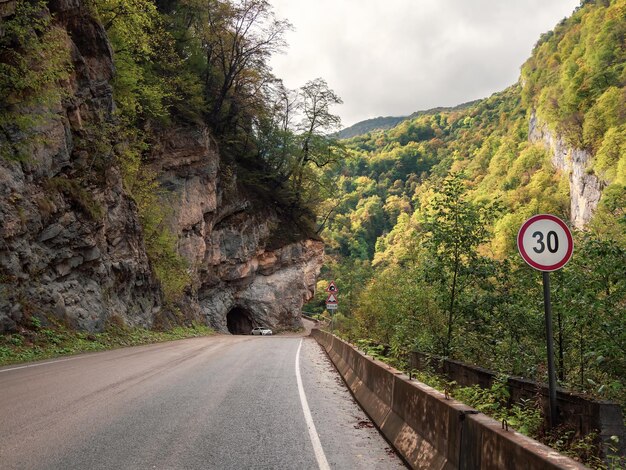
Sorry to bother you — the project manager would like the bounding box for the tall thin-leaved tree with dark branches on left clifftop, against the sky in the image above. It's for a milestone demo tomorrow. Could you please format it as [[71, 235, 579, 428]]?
[[172, 0, 291, 139]]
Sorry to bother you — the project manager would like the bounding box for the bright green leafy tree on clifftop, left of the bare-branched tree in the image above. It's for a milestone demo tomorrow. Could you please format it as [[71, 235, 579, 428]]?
[[93, 0, 205, 123]]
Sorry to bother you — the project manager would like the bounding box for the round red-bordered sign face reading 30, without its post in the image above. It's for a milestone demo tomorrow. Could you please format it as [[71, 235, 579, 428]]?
[[517, 214, 574, 271]]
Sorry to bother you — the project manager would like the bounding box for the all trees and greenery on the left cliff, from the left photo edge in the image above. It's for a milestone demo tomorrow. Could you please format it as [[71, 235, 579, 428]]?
[[0, 0, 342, 303]]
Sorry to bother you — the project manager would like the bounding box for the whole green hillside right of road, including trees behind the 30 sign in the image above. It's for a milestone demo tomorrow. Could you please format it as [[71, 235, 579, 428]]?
[[313, 0, 626, 412]]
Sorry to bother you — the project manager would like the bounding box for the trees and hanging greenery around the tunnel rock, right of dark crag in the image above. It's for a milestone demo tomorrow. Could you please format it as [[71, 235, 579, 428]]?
[[93, 0, 341, 298]]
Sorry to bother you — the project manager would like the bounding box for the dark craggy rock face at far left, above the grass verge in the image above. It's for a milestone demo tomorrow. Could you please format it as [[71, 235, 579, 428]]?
[[0, 1, 160, 331]]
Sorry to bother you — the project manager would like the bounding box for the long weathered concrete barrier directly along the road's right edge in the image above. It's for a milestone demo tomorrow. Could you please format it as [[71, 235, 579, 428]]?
[[312, 329, 585, 470]]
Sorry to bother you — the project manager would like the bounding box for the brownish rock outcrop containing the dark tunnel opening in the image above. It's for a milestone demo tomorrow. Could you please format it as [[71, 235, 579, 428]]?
[[153, 127, 324, 333]]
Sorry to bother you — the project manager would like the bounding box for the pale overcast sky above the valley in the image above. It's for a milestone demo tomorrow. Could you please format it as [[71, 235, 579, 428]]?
[[270, 0, 580, 127]]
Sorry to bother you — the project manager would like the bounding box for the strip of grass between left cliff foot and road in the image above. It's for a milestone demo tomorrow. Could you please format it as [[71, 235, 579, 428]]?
[[0, 317, 214, 366]]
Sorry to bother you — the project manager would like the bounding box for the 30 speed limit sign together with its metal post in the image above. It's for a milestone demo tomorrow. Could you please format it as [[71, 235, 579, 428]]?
[[517, 214, 574, 428]]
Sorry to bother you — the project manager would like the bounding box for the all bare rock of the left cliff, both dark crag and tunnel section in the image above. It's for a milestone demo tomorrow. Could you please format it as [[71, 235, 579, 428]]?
[[0, 0, 323, 333]]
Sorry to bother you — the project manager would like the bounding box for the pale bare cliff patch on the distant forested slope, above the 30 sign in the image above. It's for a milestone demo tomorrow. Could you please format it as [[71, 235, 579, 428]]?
[[528, 113, 603, 229]]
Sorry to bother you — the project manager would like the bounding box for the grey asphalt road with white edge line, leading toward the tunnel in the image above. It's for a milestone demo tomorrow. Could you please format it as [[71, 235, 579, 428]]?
[[0, 335, 404, 470]]
